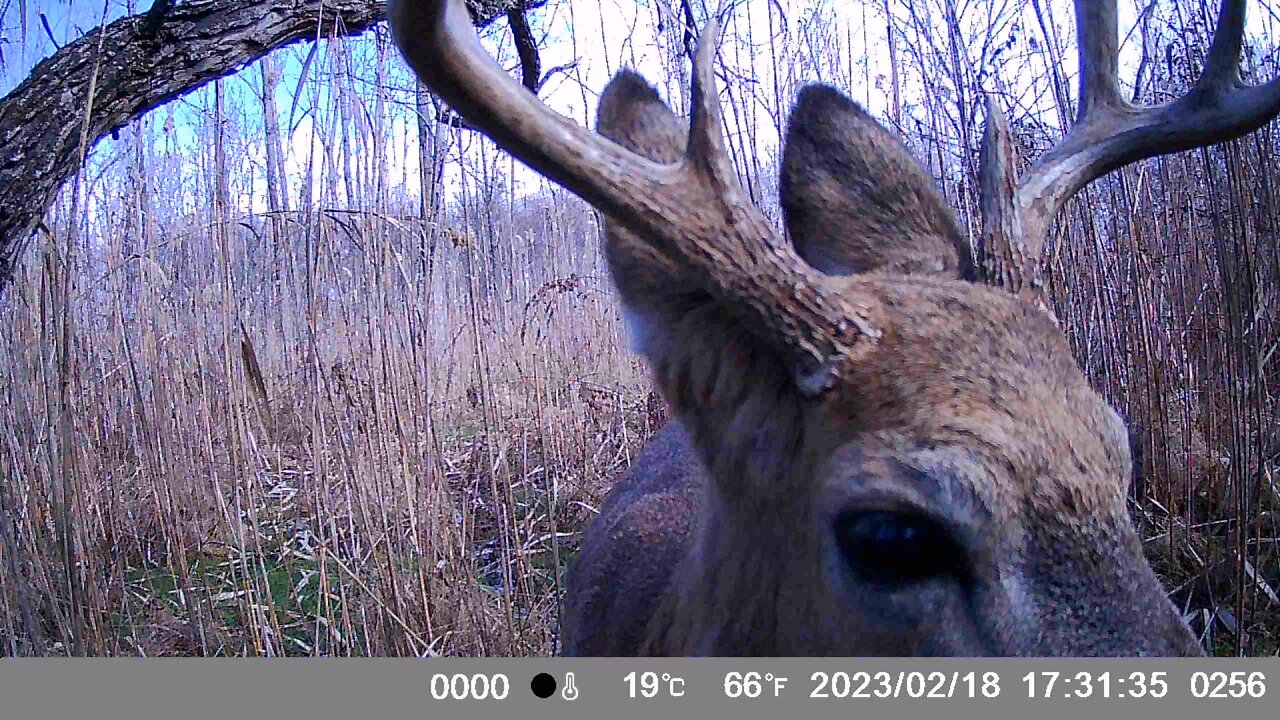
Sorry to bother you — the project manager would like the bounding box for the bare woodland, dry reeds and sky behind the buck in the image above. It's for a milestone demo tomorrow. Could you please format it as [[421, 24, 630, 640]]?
[[0, 0, 1280, 656]]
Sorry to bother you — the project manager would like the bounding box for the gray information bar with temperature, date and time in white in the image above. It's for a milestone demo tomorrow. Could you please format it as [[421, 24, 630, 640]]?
[[0, 659, 1280, 720]]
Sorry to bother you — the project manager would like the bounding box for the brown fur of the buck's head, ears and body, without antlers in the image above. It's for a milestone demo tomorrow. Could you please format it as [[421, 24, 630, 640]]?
[[563, 72, 1199, 655]]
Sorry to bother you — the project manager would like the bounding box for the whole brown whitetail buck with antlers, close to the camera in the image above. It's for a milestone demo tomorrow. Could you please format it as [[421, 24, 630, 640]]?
[[390, 0, 1280, 655]]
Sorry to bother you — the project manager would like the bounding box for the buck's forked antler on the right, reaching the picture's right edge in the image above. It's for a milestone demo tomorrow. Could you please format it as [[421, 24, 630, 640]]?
[[978, 0, 1280, 295]]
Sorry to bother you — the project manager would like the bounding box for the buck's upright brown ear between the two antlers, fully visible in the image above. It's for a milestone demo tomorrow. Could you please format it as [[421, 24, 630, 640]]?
[[781, 85, 973, 279]]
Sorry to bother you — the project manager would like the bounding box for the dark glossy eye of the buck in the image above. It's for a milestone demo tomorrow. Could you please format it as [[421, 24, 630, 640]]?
[[835, 510, 966, 589]]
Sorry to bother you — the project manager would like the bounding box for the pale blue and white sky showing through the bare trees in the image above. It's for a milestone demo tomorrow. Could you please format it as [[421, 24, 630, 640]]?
[[0, 0, 1280, 217]]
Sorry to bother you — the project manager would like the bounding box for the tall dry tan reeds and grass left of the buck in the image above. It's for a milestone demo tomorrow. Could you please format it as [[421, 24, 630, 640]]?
[[0, 193, 662, 655]]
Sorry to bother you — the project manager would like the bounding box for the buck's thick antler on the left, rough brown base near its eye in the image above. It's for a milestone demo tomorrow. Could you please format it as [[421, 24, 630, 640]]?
[[388, 0, 879, 393]]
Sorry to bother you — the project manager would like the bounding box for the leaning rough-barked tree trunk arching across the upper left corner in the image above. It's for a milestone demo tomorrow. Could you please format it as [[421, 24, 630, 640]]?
[[0, 0, 539, 288]]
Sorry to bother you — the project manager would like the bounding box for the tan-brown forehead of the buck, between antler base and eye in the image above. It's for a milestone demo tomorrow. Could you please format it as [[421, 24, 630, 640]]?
[[822, 278, 1129, 523]]
